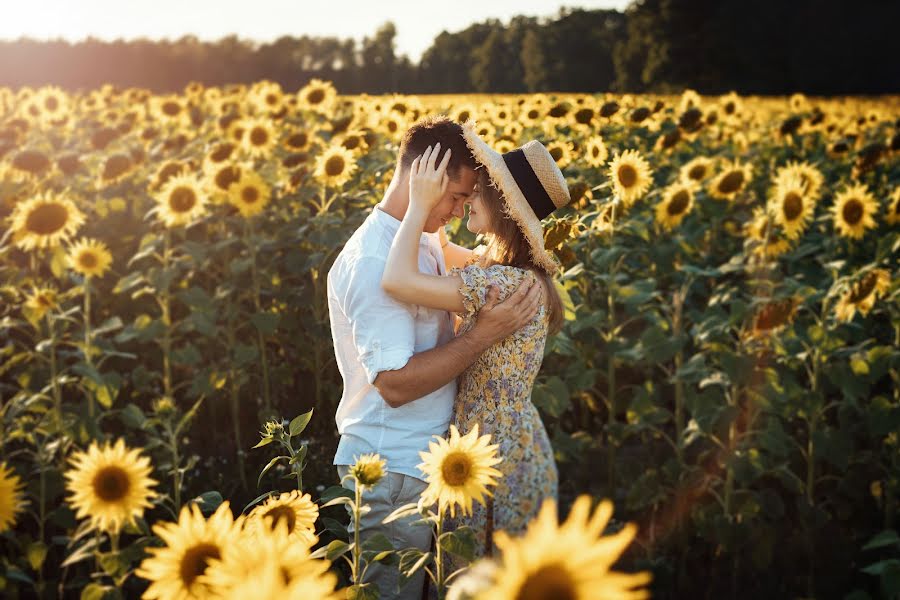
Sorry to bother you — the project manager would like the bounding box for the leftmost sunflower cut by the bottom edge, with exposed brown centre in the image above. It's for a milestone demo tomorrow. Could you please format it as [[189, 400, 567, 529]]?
[[135, 500, 243, 600]]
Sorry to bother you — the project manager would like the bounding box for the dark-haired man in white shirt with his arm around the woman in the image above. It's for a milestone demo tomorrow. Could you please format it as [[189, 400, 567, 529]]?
[[327, 117, 540, 599]]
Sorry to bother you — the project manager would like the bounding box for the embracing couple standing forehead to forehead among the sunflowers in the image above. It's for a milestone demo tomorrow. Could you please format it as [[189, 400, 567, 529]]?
[[328, 117, 569, 599]]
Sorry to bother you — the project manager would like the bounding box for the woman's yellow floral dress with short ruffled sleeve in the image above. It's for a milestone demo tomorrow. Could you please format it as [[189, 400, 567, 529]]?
[[449, 265, 558, 556]]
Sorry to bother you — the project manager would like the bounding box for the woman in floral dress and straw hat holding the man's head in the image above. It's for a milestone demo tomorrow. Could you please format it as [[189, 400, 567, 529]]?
[[382, 123, 569, 556]]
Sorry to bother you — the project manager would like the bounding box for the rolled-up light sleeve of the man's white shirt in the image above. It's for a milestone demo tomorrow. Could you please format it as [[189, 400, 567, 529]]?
[[343, 257, 416, 383]]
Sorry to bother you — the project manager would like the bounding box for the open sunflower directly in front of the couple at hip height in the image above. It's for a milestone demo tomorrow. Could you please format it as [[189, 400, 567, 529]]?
[[418, 424, 502, 517]]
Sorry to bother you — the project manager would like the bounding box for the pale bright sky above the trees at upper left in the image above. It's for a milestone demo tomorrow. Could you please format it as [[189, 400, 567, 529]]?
[[0, 0, 629, 61]]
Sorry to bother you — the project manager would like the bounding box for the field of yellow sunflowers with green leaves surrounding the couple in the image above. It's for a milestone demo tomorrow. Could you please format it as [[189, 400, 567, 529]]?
[[0, 80, 900, 600]]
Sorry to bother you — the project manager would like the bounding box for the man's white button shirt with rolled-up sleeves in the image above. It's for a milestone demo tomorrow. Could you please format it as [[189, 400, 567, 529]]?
[[327, 208, 456, 479]]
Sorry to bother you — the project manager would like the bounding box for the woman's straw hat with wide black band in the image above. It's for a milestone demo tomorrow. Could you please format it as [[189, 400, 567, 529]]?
[[462, 121, 570, 274]]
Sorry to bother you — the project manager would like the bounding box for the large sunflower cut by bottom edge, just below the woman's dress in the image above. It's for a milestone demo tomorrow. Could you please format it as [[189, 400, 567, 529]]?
[[476, 495, 651, 600]]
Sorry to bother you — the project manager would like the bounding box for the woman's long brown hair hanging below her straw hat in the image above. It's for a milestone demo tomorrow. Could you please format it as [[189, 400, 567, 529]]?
[[478, 168, 563, 335]]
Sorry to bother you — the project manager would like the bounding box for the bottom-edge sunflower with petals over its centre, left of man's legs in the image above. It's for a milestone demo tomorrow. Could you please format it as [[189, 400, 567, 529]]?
[[203, 522, 345, 600]]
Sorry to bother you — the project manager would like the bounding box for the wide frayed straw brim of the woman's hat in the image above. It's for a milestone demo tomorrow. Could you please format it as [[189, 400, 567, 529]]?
[[462, 121, 560, 275]]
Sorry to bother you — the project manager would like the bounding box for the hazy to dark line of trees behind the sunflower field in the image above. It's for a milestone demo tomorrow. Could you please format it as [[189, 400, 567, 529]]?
[[0, 0, 900, 95]]
